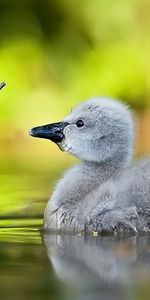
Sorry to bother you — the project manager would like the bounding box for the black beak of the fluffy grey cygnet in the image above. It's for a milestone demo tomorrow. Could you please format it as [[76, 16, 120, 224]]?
[[29, 122, 68, 143]]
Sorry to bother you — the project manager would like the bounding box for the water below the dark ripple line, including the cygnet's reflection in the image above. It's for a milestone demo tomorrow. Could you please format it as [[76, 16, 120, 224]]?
[[0, 224, 150, 300]]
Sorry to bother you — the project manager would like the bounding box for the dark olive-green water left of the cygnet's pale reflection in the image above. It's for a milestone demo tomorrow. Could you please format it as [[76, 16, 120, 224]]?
[[0, 227, 64, 300]]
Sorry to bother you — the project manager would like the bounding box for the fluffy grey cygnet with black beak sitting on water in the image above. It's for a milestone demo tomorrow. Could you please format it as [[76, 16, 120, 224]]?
[[30, 98, 150, 231]]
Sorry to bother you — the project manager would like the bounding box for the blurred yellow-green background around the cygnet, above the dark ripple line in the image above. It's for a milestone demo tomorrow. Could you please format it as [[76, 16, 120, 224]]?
[[0, 0, 150, 220]]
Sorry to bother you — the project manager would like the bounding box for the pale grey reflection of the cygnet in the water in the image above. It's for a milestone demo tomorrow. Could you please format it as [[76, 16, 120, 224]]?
[[43, 234, 150, 300]]
